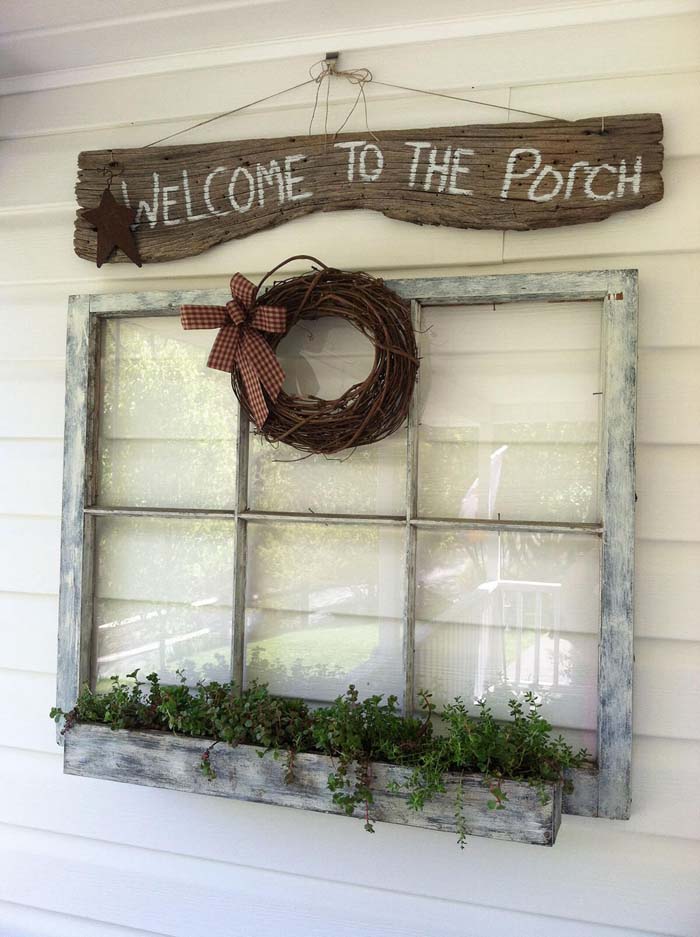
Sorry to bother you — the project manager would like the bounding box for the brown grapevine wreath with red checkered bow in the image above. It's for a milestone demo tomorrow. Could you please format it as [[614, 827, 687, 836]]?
[[181, 254, 418, 455]]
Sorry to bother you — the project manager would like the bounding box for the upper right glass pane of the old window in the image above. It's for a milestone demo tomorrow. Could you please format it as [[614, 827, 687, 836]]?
[[418, 302, 602, 523]]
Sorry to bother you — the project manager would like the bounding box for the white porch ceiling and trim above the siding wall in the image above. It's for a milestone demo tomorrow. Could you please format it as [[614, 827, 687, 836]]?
[[0, 0, 698, 93]]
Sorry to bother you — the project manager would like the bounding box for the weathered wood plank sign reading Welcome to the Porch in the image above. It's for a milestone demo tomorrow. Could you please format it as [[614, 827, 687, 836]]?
[[75, 114, 663, 263]]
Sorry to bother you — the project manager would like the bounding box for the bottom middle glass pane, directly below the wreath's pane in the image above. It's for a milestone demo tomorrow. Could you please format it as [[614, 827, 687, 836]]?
[[246, 523, 404, 701]]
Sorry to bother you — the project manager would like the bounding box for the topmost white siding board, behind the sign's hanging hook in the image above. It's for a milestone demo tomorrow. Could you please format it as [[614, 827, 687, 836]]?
[[0, 14, 700, 139]]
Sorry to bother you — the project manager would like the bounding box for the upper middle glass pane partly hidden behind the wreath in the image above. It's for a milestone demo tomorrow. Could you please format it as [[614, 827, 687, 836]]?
[[249, 319, 406, 515]]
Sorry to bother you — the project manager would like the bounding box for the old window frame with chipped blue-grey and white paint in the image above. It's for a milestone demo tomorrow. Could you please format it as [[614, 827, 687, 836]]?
[[57, 270, 638, 819]]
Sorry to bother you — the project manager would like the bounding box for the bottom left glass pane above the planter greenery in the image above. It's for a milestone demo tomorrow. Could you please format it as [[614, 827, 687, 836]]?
[[94, 517, 234, 689]]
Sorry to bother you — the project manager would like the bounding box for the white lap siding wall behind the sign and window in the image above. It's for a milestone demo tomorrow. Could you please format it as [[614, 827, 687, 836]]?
[[0, 15, 700, 937]]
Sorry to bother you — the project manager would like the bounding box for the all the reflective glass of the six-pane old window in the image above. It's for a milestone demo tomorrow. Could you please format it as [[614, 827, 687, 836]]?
[[94, 294, 602, 750]]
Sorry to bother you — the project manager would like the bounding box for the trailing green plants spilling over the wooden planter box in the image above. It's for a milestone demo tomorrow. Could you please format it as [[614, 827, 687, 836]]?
[[51, 670, 587, 847]]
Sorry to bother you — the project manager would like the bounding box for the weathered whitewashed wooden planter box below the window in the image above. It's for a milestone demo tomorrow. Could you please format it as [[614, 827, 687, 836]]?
[[64, 724, 562, 846]]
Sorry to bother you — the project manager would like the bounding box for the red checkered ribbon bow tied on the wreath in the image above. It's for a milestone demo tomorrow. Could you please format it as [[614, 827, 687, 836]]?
[[180, 273, 287, 428]]
